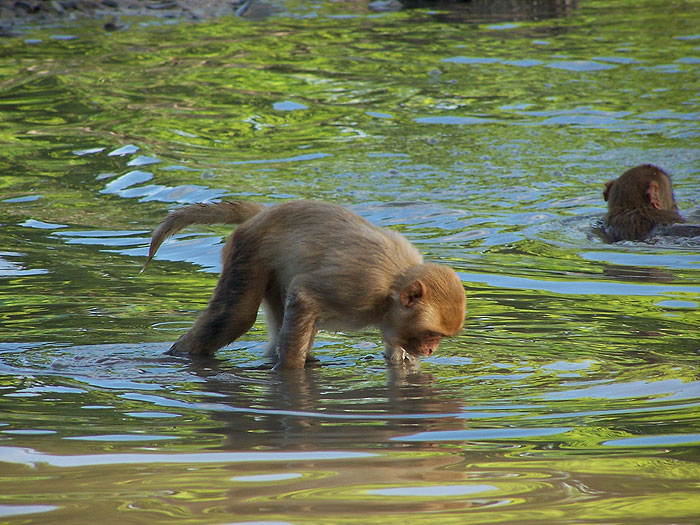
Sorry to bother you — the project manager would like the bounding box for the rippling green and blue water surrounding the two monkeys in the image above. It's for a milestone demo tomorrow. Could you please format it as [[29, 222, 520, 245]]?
[[0, 0, 700, 524]]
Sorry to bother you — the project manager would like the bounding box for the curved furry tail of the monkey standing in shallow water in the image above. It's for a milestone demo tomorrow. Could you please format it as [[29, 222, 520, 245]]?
[[141, 201, 265, 273]]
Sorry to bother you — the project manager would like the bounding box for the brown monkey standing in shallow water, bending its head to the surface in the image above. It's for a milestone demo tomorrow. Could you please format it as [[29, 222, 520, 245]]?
[[144, 201, 466, 368]]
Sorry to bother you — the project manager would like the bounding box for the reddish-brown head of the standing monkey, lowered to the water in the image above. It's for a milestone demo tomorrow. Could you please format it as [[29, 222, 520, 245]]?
[[381, 263, 466, 361]]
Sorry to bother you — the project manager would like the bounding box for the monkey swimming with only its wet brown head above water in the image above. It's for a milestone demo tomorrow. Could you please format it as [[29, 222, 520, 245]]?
[[603, 164, 688, 242]]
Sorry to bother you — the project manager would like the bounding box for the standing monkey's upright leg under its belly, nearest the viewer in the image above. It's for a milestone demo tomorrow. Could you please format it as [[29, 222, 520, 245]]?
[[274, 292, 318, 370]]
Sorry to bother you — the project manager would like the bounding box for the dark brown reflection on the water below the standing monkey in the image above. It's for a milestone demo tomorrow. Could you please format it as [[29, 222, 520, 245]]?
[[182, 359, 465, 450]]
